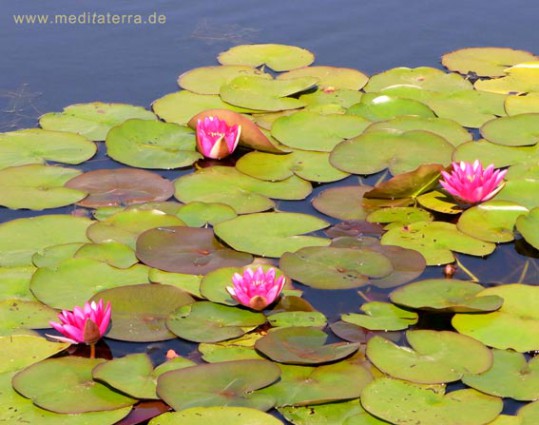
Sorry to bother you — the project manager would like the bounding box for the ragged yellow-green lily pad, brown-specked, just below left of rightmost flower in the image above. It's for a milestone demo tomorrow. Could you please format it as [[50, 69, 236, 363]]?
[[382, 221, 496, 265]]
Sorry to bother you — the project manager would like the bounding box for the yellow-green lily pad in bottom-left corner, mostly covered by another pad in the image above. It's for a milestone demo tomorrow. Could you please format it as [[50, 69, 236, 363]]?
[[0, 372, 131, 425]]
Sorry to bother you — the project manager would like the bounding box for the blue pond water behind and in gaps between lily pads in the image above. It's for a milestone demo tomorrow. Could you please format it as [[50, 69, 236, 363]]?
[[4, 0, 539, 422]]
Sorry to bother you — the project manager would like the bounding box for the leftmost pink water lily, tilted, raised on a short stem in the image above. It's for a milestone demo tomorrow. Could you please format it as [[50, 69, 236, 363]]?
[[48, 300, 111, 345]]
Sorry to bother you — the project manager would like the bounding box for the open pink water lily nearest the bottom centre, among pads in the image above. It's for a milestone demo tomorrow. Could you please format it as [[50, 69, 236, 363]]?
[[226, 267, 285, 310]]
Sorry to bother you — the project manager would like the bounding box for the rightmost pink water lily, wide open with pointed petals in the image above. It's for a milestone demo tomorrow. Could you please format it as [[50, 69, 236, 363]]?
[[440, 160, 507, 204]]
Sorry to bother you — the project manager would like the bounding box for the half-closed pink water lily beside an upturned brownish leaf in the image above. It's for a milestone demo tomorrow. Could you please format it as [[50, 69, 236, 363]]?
[[196, 117, 241, 159]]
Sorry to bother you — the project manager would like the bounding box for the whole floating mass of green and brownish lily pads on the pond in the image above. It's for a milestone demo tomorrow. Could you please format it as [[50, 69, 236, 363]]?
[[0, 44, 539, 425]]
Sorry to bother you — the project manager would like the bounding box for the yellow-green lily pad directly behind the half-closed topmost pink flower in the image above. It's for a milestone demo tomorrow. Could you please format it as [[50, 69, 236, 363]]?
[[152, 90, 255, 125]]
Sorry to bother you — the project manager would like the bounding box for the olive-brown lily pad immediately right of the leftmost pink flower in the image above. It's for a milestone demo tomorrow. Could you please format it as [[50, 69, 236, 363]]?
[[93, 283, 195, 342]]
